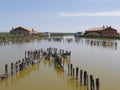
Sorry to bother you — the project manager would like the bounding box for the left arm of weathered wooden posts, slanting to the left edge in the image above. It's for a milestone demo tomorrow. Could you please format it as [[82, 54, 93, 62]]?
[[0, 50, 41, 80]]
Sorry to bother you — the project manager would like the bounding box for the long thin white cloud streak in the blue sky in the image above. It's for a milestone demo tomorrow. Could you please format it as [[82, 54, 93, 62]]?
[[58, 11, 120, 17]]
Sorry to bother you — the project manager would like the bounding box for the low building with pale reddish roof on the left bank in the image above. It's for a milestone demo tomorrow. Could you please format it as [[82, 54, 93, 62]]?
[[10, 26, 36, 35]]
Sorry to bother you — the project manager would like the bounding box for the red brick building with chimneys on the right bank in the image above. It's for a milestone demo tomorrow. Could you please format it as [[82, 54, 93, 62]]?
[[85, 26, 117, 37]]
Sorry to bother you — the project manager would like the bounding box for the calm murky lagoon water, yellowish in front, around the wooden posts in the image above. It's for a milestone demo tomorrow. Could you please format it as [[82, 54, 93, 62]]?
[[0, 37, 120, 90]]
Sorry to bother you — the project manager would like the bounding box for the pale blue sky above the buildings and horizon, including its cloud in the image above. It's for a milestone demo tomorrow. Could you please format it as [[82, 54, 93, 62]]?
[[0, 0, 120, 32]]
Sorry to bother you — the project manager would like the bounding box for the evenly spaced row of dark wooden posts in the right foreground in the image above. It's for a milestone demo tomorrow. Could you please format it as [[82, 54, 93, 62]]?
[[68, 64, 100, 90]]
